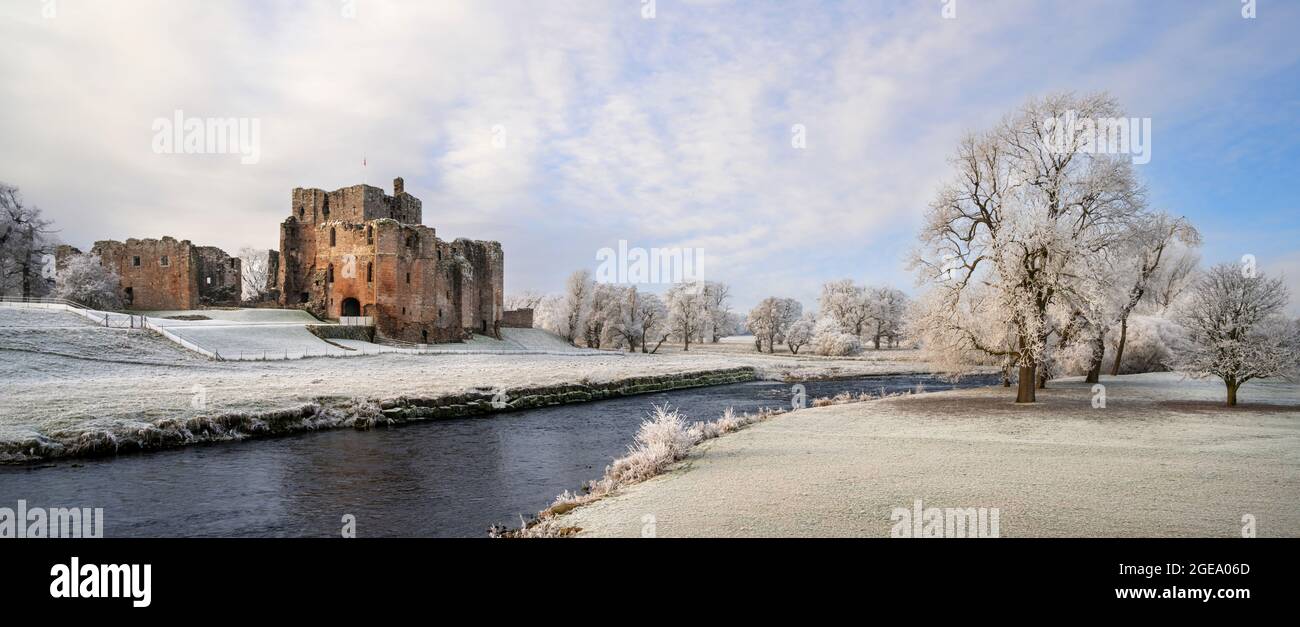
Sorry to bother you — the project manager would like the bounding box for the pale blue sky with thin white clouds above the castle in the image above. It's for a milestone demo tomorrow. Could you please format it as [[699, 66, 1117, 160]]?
[[0, 0, 1300, 311]]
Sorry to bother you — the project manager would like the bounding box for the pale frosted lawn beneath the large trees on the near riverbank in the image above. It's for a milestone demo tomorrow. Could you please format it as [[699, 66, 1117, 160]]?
[[556, 373, 1300, 537]]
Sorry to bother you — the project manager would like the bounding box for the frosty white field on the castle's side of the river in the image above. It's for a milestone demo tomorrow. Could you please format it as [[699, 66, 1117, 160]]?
[[0, 308, 926, 460]]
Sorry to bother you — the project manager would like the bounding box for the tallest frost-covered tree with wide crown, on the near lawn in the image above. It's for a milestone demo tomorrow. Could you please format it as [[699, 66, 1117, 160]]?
[[911, 94, 1144, 402]]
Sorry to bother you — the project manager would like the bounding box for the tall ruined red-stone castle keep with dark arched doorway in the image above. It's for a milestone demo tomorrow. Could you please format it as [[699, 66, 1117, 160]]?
[[274, 178, 503, 342]]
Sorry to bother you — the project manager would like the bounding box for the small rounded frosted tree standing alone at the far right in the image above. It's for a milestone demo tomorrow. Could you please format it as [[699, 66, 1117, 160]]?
[[1175, 264, 1300, 406]]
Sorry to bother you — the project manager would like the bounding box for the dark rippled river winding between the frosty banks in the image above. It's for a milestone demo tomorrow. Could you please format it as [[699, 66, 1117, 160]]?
[[0, 375, 998, 537]]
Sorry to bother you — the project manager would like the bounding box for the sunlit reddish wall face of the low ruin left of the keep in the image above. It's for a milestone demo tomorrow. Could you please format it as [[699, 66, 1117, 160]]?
[[91, 237, 199, 311]]
